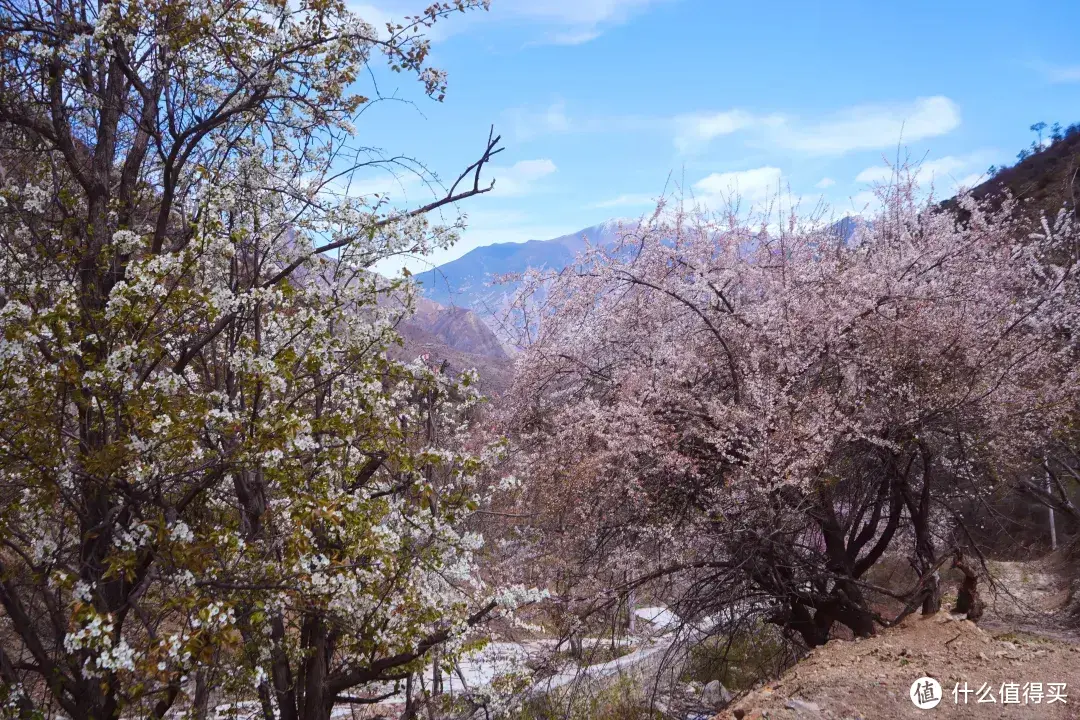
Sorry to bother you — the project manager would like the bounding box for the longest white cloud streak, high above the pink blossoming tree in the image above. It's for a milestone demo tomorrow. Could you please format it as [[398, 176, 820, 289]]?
[[675, 95, 960, 155]]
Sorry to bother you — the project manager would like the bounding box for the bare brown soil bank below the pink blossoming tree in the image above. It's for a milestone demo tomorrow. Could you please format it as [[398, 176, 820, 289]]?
[[717, 612, 1080, 720]]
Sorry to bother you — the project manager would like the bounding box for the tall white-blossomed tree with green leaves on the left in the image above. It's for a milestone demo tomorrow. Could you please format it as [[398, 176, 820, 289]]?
[[0, 0, 540, 720]]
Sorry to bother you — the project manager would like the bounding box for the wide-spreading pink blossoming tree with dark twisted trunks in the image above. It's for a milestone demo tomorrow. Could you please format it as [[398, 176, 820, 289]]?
[[507, 179, 1080, 647]]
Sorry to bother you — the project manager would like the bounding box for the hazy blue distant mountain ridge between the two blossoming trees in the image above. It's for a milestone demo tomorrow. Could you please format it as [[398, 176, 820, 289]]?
[[416, 220, 619, 315]]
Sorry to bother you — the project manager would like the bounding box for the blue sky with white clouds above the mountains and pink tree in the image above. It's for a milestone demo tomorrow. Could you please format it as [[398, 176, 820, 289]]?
[[352, 0, 1080, 272]]
